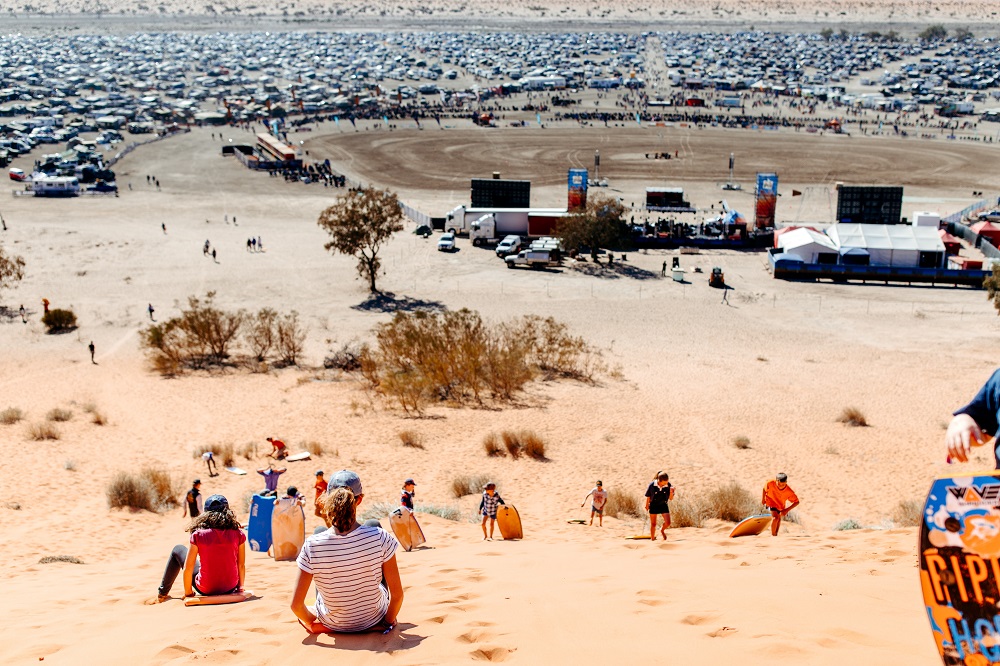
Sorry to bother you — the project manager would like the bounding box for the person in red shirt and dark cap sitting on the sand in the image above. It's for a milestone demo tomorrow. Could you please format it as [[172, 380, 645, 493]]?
[[156, 495, 247, 602]]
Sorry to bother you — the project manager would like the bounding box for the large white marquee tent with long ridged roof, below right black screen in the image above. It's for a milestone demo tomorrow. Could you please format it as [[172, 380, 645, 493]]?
[[828, 223, 945, 268]]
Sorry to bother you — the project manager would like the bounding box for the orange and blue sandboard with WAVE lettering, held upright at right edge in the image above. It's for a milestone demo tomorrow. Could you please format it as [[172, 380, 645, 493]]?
[[919, 471, 1000, 665]]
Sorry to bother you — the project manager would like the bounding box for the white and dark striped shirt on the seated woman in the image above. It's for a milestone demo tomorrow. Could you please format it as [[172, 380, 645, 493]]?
[[298, 525, 399, 631]]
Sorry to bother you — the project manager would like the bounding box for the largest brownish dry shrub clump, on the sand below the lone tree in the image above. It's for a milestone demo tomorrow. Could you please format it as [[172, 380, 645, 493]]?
[[358, 309, 601, 413]]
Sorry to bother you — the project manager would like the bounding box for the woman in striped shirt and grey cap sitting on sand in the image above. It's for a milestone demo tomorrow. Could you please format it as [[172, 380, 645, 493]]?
[[292, 470, 403, 634]]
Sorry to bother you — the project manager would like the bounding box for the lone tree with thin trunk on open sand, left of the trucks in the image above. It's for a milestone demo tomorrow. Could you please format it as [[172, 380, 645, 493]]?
[[317, 187, 403, 293]]
